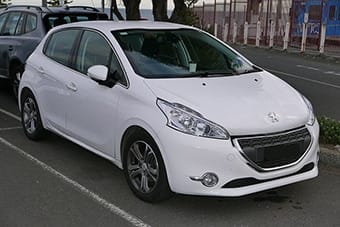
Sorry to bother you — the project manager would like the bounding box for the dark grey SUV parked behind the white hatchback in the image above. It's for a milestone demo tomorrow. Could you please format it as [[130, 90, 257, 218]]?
[[0, 5, 108, 96]]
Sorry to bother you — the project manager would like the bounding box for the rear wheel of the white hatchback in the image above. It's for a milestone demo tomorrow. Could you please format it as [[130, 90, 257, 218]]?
[[21, 91, 46, 140]]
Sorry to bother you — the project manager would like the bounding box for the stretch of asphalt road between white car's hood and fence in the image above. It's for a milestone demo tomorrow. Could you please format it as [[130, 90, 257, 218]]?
[[235, 46, 340, 120]]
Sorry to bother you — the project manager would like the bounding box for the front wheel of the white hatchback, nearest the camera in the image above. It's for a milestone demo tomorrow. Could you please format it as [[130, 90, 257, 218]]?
[[123, 130, 172, 203]]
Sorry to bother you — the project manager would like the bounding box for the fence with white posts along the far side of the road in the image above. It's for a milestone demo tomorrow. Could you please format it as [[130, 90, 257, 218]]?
[[193, 0, 340, 55]]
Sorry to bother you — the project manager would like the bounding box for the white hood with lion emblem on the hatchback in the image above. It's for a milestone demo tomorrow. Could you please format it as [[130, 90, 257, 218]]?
[[145, 71, 309, 136]]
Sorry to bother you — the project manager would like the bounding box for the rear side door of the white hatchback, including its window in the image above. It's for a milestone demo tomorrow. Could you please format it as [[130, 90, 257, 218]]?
[[34, 29, 80, 132]]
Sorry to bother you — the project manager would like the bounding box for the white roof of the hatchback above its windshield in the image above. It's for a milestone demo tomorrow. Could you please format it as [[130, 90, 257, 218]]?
[[53, 20, 197, 31]]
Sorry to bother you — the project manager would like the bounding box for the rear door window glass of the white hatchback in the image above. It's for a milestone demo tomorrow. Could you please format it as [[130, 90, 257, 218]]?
[[44, 30, 79, 65]]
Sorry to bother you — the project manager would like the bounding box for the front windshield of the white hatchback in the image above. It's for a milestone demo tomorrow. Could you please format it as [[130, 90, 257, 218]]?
[[112, 29, 260, 78]]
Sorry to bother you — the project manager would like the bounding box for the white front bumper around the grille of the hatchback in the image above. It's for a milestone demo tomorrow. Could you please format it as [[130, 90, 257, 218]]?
[[158, 122, 319, 197]]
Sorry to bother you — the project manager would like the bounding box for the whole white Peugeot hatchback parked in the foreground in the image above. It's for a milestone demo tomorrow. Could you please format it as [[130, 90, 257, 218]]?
[[19, 21, 319, 202]]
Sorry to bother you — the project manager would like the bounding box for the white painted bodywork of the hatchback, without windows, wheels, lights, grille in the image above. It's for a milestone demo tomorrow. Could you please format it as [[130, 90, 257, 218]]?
[[19, 22, 319, 199]]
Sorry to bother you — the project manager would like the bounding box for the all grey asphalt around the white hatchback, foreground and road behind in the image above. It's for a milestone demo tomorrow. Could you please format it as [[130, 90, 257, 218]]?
[[0, 49, 340, 227]]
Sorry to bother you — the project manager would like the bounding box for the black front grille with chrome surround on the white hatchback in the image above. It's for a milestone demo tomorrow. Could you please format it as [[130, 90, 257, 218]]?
[[236, 127, 311, 170]]
